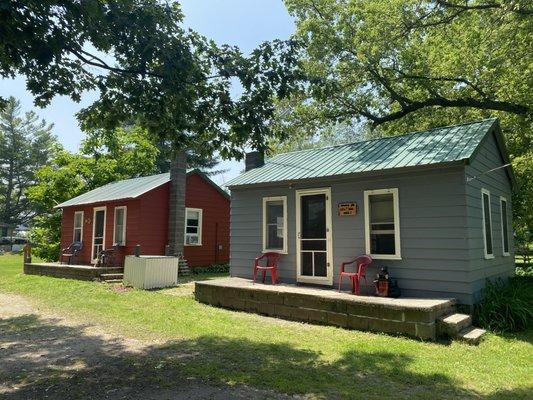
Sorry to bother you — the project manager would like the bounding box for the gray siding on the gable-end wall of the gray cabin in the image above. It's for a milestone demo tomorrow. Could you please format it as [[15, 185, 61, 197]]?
[[465, 133, 514, 298]]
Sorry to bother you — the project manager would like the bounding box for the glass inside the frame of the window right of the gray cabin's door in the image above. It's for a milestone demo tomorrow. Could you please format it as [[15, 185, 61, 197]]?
[[368, 193, 396, 255]]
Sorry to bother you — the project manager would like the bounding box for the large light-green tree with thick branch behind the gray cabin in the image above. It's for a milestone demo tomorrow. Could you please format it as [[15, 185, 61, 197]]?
[[275, 0, 533, 244]]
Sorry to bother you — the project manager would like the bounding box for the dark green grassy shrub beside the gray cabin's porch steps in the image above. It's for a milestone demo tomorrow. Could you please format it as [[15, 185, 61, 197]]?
[[474, 276, 533, 333]]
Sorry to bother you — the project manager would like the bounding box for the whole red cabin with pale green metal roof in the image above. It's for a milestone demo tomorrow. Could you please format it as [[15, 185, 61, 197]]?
[[57, 170, 230, 267]]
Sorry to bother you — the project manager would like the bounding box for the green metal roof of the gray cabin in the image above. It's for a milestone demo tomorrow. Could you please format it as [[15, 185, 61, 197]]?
[[227, 118, 497, 187]]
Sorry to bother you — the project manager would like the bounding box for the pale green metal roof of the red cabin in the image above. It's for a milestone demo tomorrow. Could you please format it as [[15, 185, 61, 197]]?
[[55, 169, 229, 208]]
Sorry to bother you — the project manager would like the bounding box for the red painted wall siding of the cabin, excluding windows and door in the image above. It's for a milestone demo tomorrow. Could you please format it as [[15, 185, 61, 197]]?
[[61, 174, 230, 267]]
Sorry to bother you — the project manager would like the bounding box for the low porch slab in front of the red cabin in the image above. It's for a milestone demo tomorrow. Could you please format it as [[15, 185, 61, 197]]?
[[24, 262, 124, 281]]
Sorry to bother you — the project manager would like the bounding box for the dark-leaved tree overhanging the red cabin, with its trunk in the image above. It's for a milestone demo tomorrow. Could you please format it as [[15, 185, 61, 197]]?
[[0, 0, 297, 255]]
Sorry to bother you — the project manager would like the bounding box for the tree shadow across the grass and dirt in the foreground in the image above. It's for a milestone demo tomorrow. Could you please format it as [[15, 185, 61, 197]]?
[[0, 315, 531, 399]]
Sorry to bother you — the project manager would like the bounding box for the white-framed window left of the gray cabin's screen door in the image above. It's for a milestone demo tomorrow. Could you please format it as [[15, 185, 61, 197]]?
[[263, 196, 287, 253]]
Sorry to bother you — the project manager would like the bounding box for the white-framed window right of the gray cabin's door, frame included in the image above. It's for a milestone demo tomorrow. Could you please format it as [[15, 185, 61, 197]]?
[[365, 189, 401, 260]]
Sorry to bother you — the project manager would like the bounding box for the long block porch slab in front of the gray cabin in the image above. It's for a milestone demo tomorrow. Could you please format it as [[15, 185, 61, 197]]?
[[195, 278, 456, 340]]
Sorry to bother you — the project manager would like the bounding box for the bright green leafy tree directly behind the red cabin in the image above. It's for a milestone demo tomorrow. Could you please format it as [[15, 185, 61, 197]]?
[[28, 126, 159, 260]]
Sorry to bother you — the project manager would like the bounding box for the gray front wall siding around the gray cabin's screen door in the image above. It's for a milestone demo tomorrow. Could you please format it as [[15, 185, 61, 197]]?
[[231, 165, 473, 304]]
